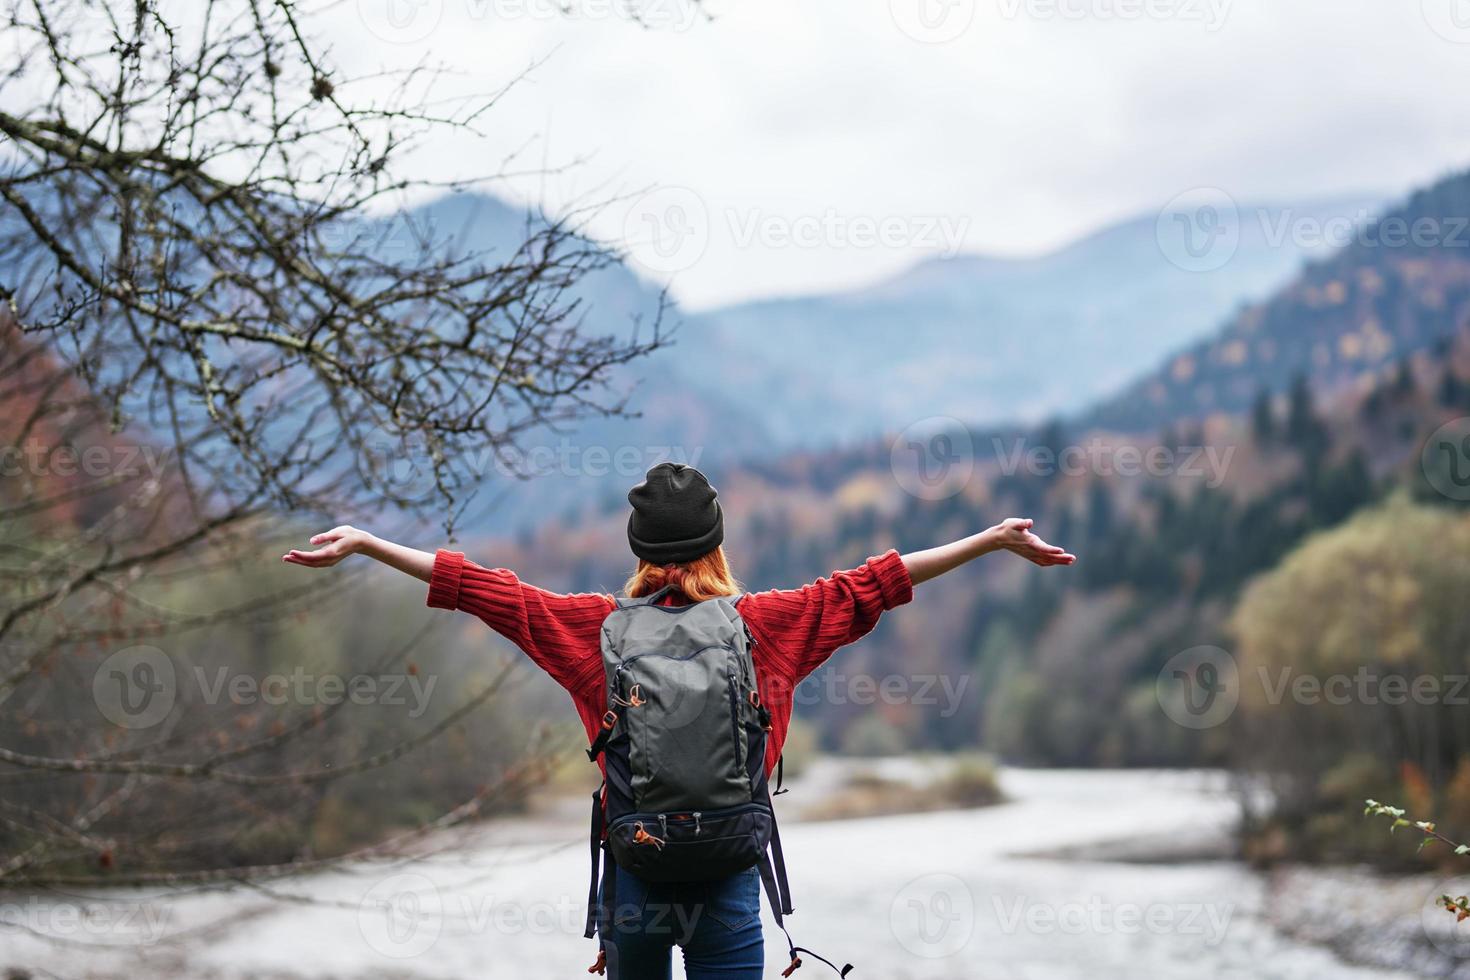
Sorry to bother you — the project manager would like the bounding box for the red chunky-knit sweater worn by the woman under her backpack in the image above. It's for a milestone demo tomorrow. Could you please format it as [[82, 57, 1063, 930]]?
[[429, 550, 913, 771]]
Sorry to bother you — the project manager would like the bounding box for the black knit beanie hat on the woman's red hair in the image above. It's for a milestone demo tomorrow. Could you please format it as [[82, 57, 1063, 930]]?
[[628, 463, 725, 564]]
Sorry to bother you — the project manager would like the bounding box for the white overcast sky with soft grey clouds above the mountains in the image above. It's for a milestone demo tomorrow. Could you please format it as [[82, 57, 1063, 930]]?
[[315, 0, 1470, 309]]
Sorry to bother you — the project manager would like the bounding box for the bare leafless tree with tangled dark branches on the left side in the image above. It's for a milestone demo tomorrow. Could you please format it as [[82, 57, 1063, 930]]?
[[0, 0, 664, 884]]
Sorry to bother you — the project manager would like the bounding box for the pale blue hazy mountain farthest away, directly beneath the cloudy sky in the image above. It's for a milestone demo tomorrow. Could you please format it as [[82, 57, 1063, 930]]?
[[669, 198, 1376, 448]]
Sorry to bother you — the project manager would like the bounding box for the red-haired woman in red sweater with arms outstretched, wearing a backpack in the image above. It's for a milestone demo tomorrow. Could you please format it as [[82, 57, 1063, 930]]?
[[284, 463, 1076, 980]]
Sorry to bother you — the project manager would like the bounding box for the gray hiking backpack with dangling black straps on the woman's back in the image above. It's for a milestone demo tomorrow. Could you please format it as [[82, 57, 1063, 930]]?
[[587, 586, 851, 977]]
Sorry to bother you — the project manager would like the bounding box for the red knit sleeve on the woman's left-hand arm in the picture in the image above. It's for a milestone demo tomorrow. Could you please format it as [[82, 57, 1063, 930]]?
[[428, 550, 614, 695]]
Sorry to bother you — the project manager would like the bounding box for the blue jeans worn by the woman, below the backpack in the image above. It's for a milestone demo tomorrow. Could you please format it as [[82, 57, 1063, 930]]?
[[604, 868, 766, 980]]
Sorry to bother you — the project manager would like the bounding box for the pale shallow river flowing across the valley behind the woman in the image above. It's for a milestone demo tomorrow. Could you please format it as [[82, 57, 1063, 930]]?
[[0, 763, 1408, 980]]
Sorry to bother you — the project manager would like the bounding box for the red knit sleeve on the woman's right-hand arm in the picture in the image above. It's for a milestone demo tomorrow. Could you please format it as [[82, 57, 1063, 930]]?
[[739, 550, 913, 685]]
